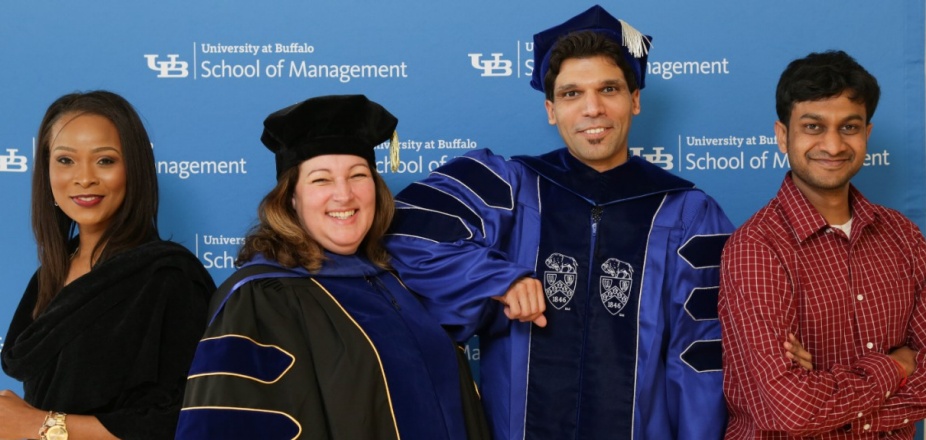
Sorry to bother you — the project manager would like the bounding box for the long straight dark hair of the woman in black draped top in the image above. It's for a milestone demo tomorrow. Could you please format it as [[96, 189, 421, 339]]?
[[32, 90, 158, 317]]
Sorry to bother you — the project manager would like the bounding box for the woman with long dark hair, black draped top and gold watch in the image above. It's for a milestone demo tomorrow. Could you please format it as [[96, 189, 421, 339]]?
[[0, 91, 215, 440]]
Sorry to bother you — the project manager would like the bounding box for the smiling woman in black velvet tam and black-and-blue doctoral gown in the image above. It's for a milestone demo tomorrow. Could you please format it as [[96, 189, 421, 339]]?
[[177, 95, 487, 440]]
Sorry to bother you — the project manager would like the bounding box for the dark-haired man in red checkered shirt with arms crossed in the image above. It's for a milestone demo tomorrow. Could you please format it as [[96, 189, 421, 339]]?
[[719, 51, 926, 439]]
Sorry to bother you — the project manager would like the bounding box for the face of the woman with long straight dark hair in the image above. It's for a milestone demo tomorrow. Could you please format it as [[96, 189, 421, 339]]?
[[48, 113, 126, 236]]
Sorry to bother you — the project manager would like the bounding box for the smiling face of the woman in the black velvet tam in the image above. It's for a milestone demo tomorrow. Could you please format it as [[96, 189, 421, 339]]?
[[293, 154, 376, 255]]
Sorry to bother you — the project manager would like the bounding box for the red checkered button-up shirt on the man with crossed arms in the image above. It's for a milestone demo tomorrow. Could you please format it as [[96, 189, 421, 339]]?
[[719, 175, 926, 439]]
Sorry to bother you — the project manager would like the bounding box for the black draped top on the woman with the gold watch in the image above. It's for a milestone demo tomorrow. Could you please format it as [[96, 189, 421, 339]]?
[[2, 240, 215, 439]]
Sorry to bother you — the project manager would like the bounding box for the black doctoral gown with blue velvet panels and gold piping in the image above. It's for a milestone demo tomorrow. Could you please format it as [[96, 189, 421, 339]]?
[[177, 254, 488, 440]]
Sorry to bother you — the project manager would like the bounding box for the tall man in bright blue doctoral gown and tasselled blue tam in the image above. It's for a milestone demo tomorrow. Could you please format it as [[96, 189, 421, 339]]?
[[387, 6, 733, 440]]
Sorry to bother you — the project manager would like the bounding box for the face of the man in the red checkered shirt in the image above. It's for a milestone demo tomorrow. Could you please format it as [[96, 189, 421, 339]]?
[[775, 93, 872, 197]]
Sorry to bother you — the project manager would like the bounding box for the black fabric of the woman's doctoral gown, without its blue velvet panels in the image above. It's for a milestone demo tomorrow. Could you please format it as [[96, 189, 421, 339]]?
[[178, 265, 490, 440]]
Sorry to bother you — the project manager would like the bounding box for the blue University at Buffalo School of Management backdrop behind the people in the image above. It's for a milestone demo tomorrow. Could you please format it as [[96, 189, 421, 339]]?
[[0, 0, 926, 426]]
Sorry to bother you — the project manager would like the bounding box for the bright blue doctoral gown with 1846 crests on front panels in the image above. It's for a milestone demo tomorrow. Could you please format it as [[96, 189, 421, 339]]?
[[386, 149, 733, 440]]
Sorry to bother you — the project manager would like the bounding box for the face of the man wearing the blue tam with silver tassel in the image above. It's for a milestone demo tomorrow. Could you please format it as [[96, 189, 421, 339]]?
[[546, 56, 640, 172]]
